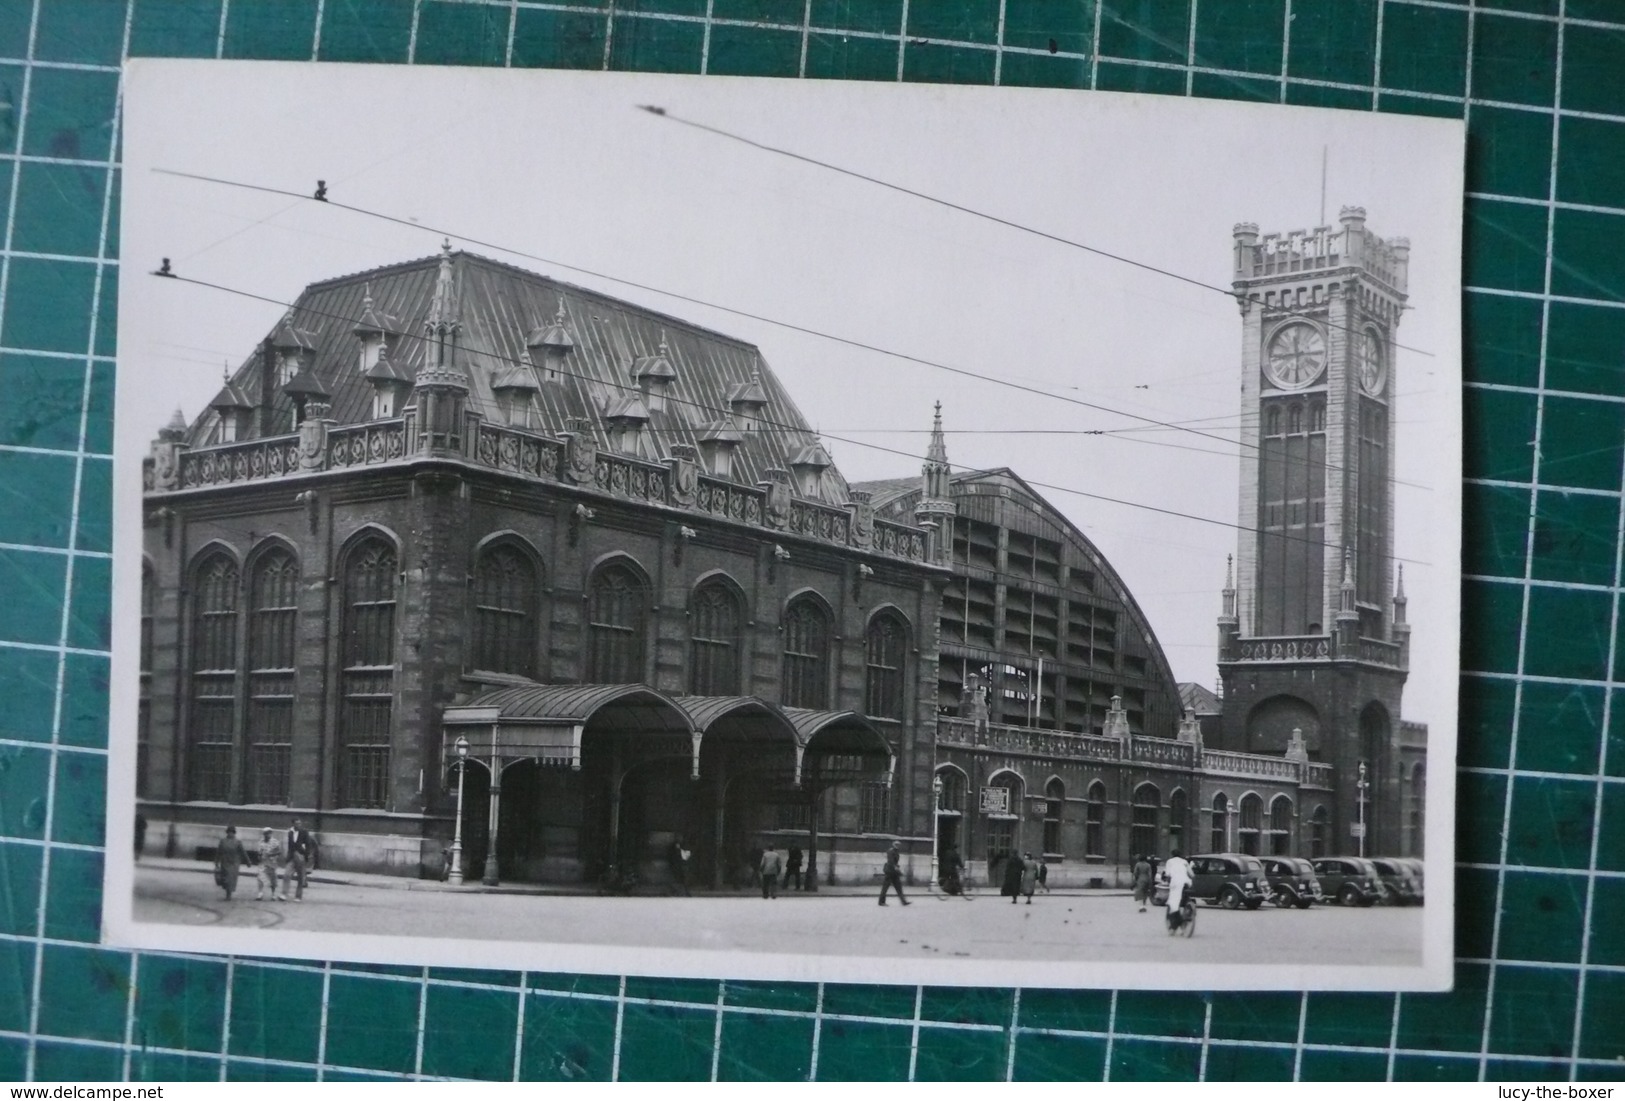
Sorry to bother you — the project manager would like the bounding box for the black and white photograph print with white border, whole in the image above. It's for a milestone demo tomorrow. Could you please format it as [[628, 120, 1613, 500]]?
[[104, 60, 1464, 991]]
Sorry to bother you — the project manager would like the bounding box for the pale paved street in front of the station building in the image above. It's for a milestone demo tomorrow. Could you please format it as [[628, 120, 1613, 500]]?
[[135, 862, 1422, 966]]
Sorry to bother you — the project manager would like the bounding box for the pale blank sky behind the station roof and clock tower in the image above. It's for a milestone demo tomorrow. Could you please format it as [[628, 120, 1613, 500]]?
[[115, 60, 1463, 734]]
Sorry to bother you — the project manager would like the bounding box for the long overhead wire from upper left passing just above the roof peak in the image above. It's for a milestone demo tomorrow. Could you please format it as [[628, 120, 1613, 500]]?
[[153, 169, 1404, 487]]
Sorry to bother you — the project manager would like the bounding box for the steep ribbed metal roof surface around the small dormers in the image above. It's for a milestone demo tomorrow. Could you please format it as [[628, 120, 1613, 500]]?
[[189, 252, 847, 502]]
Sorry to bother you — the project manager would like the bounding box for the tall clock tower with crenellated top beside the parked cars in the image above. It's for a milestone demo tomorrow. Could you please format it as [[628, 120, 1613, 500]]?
[[1219, 206, 1411, 856]]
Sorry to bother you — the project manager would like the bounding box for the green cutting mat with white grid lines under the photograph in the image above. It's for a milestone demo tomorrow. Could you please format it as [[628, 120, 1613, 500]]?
[[0, 0, 1625, 1080]]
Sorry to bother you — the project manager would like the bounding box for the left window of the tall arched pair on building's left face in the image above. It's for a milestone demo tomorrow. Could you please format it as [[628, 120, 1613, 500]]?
[[187, 552, 241, 802]]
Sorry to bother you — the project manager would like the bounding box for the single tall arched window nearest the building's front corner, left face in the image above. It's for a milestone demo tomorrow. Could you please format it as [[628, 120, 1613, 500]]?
[[340, 538, 398, 807]]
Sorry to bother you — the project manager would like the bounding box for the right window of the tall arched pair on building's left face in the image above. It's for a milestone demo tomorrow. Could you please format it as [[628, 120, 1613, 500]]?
[[247, 547, 299, 804]]
